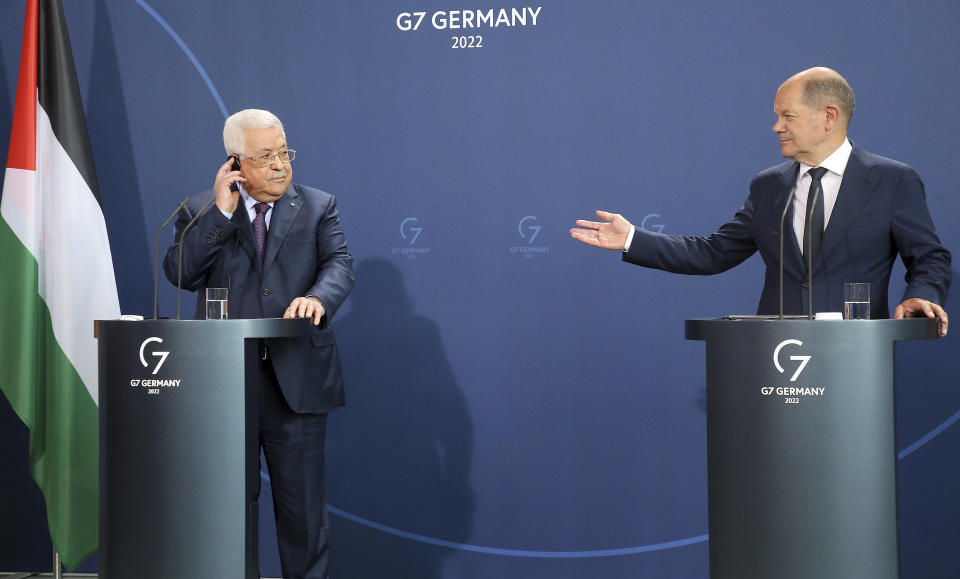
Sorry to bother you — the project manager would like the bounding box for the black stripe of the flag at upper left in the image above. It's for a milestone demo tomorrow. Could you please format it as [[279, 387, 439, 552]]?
[[37, 0, 100, 203]]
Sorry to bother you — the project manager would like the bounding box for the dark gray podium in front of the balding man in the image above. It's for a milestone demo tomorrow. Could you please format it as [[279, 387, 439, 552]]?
[[686, 319, 937, 579]]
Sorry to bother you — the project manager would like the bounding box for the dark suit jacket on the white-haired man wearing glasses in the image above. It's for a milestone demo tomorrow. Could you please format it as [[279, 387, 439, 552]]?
[[163, 184, 353, 413]]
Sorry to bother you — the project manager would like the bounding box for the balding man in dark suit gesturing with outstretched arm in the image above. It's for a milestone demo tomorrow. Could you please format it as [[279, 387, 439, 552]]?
[[570, 68, 952, 336]]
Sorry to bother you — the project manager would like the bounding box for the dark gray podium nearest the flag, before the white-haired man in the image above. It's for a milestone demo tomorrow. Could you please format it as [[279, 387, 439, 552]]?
[[96, 319, 309, 579]]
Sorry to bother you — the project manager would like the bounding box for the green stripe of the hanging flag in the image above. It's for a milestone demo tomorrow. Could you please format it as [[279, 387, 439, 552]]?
[[0, 219, 99, 569]]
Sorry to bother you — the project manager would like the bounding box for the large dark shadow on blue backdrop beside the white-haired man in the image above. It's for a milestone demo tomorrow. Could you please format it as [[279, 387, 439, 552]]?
[[327, 259, 479, 579]]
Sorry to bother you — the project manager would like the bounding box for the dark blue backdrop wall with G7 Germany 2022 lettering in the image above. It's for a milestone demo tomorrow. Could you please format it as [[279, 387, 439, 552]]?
[[0, 0, 960, 579]]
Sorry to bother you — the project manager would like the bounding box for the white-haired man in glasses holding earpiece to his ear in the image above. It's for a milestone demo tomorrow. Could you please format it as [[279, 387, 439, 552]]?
[[164, 109, 353, 579]]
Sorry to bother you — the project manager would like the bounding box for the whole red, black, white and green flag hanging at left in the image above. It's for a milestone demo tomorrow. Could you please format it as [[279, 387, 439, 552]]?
[[0, 0, 120, 569]]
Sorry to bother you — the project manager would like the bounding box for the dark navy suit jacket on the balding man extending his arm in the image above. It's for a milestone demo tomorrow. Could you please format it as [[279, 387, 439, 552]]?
[[623, 147, 951, 318]]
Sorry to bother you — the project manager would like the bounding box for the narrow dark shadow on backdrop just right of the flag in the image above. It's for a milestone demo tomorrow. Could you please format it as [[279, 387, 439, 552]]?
[[86, 0, 152, 315]]
